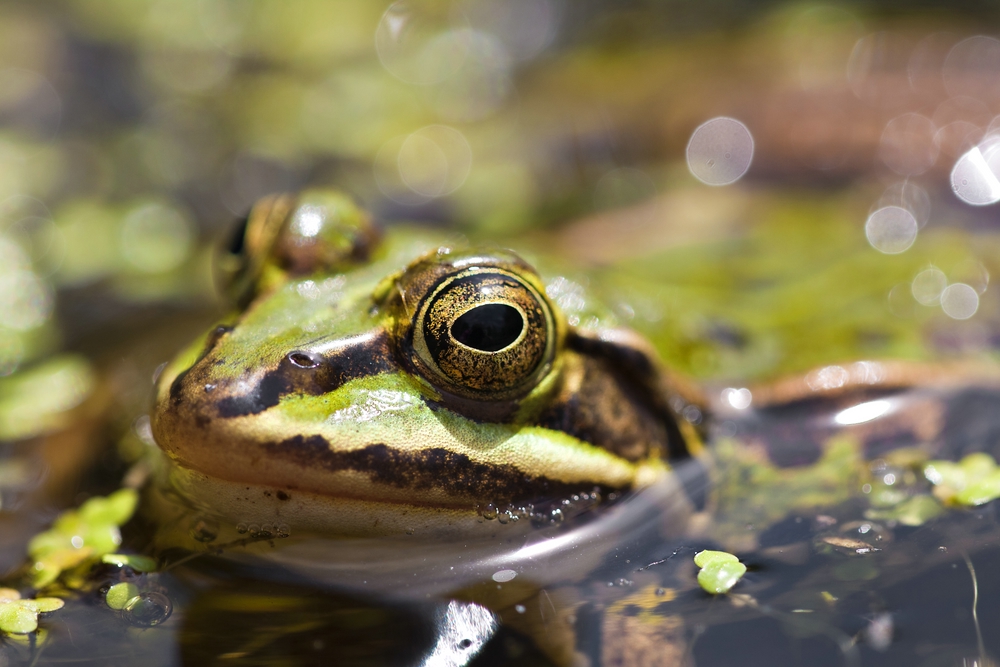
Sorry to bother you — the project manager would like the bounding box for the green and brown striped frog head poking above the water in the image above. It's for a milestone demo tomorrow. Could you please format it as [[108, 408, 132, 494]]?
[[153, 191, 694, 535]]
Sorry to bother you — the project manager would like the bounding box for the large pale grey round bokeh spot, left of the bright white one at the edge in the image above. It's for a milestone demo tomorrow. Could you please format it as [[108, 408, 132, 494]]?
[[687, 117, 753, 185]]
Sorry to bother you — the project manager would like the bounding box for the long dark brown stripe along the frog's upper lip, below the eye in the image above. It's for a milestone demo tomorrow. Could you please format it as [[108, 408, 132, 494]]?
[[263, 435, 612, 503]]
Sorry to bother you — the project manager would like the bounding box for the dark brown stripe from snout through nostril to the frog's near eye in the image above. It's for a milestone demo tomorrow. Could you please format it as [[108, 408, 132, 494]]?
[[216, 329, 397, 418]]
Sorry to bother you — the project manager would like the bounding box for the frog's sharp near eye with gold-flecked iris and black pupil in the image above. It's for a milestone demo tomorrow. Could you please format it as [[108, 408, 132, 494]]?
[[413, 267, 555, 400]]
